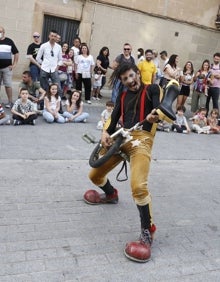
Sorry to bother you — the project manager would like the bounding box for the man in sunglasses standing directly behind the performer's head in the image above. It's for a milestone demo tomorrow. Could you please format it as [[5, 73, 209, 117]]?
[[111, 43, 135, 103]]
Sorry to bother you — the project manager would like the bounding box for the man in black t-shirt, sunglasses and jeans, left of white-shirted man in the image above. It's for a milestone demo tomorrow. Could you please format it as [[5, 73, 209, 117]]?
[[27, 31, 41, 81]]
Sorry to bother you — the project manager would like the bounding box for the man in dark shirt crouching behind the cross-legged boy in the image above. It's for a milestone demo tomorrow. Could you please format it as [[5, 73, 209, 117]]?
[[19, 71, 46, 110]]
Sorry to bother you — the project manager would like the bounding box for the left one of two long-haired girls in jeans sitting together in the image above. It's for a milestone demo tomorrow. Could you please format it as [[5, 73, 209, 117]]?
[[43, 83, 65, 123]]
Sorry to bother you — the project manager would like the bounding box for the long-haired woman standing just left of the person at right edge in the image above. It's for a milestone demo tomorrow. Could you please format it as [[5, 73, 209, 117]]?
[[191, 60, 211, 113]]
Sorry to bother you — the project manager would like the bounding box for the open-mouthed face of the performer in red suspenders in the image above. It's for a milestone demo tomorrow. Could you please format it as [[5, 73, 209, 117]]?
[[120, 69, 141, 91]]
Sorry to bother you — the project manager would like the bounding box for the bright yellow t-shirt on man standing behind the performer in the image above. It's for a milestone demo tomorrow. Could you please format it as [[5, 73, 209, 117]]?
[[138, 60, 157, 84]]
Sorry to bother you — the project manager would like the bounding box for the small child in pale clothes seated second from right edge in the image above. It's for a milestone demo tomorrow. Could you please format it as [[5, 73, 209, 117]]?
[[192, 108, 210, 134]]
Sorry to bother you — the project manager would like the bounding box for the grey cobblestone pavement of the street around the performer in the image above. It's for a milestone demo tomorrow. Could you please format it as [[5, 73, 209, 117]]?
[[0, 84, 220, 282]]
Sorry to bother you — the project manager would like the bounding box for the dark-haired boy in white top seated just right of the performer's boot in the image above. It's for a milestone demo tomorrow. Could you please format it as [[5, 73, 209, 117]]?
[[171, 106, 190, 133]]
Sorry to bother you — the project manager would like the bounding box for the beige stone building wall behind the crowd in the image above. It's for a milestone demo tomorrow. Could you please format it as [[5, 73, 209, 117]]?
[[0, 0, 220, 78]]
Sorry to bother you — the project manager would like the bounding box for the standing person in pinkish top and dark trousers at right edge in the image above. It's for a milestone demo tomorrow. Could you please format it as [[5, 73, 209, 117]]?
[[206, 53, 220, 113]]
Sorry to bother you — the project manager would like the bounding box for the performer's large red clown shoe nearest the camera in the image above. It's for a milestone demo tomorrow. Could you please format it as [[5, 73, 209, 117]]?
[[124, 225, 156, 262]]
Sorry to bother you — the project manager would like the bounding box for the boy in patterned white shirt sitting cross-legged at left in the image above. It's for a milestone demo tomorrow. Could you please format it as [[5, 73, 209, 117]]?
[[11, 88, 37, 125]]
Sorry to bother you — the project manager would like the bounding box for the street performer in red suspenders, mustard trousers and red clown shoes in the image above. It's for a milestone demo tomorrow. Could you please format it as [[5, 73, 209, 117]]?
[[84, 64, 178, 262]]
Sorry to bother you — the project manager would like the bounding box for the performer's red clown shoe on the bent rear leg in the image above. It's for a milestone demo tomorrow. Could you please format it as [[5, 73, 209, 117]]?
[[83, 188, 118, 205]]
